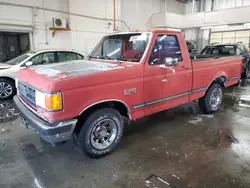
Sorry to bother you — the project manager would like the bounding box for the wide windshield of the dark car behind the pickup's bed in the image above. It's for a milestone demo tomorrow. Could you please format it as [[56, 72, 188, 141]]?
[[201, 45, 235, 56]]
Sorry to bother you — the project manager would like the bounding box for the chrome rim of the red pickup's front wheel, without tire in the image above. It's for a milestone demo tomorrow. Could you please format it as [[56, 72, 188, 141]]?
[[90, 119, 118, 150]]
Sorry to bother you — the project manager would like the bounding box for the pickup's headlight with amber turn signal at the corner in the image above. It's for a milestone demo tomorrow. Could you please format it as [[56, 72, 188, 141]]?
[[36, 91, 62, 111]]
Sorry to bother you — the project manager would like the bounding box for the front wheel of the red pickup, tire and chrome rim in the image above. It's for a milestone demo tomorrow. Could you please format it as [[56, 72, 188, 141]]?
[[77, 108, 124, 158]]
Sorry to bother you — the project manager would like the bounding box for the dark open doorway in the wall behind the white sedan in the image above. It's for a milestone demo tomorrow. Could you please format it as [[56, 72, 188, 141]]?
[[0, 32, 30, 62]]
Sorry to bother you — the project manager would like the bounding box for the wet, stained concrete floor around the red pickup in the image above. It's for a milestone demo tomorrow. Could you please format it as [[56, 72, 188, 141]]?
[[0, 80, 250, 188]]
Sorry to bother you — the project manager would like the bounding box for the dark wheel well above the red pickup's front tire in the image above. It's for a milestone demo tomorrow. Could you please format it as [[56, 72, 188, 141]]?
[[74, 101, 130, 133]]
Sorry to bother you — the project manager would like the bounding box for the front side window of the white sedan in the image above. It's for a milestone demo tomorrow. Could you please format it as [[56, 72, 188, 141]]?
[[31, 52, 55, 65]]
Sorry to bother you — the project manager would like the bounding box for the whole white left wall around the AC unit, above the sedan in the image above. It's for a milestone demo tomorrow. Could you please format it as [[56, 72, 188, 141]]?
[[0, 0, 131, 54]]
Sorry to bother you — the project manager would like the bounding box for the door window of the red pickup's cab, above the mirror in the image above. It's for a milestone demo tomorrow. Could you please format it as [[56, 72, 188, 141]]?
[[150, 35, 182, 65]]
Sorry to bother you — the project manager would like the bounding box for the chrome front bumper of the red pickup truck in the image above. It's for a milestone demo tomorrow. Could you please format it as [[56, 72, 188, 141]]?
[[14, 96, 77, 145]]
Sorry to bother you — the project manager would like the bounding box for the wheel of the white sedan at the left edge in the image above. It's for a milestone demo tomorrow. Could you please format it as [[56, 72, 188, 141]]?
[[0, 78, 16, 100]]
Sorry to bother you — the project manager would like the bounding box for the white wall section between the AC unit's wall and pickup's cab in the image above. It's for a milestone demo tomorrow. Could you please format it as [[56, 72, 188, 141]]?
[[70, 0, 120, 54]]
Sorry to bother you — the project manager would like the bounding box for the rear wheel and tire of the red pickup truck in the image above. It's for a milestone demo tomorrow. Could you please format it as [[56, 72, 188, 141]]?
[[199, 83, 223, 114]]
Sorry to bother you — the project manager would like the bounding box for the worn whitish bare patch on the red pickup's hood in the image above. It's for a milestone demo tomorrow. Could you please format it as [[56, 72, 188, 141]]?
[[33, 60, 124, 78]]
